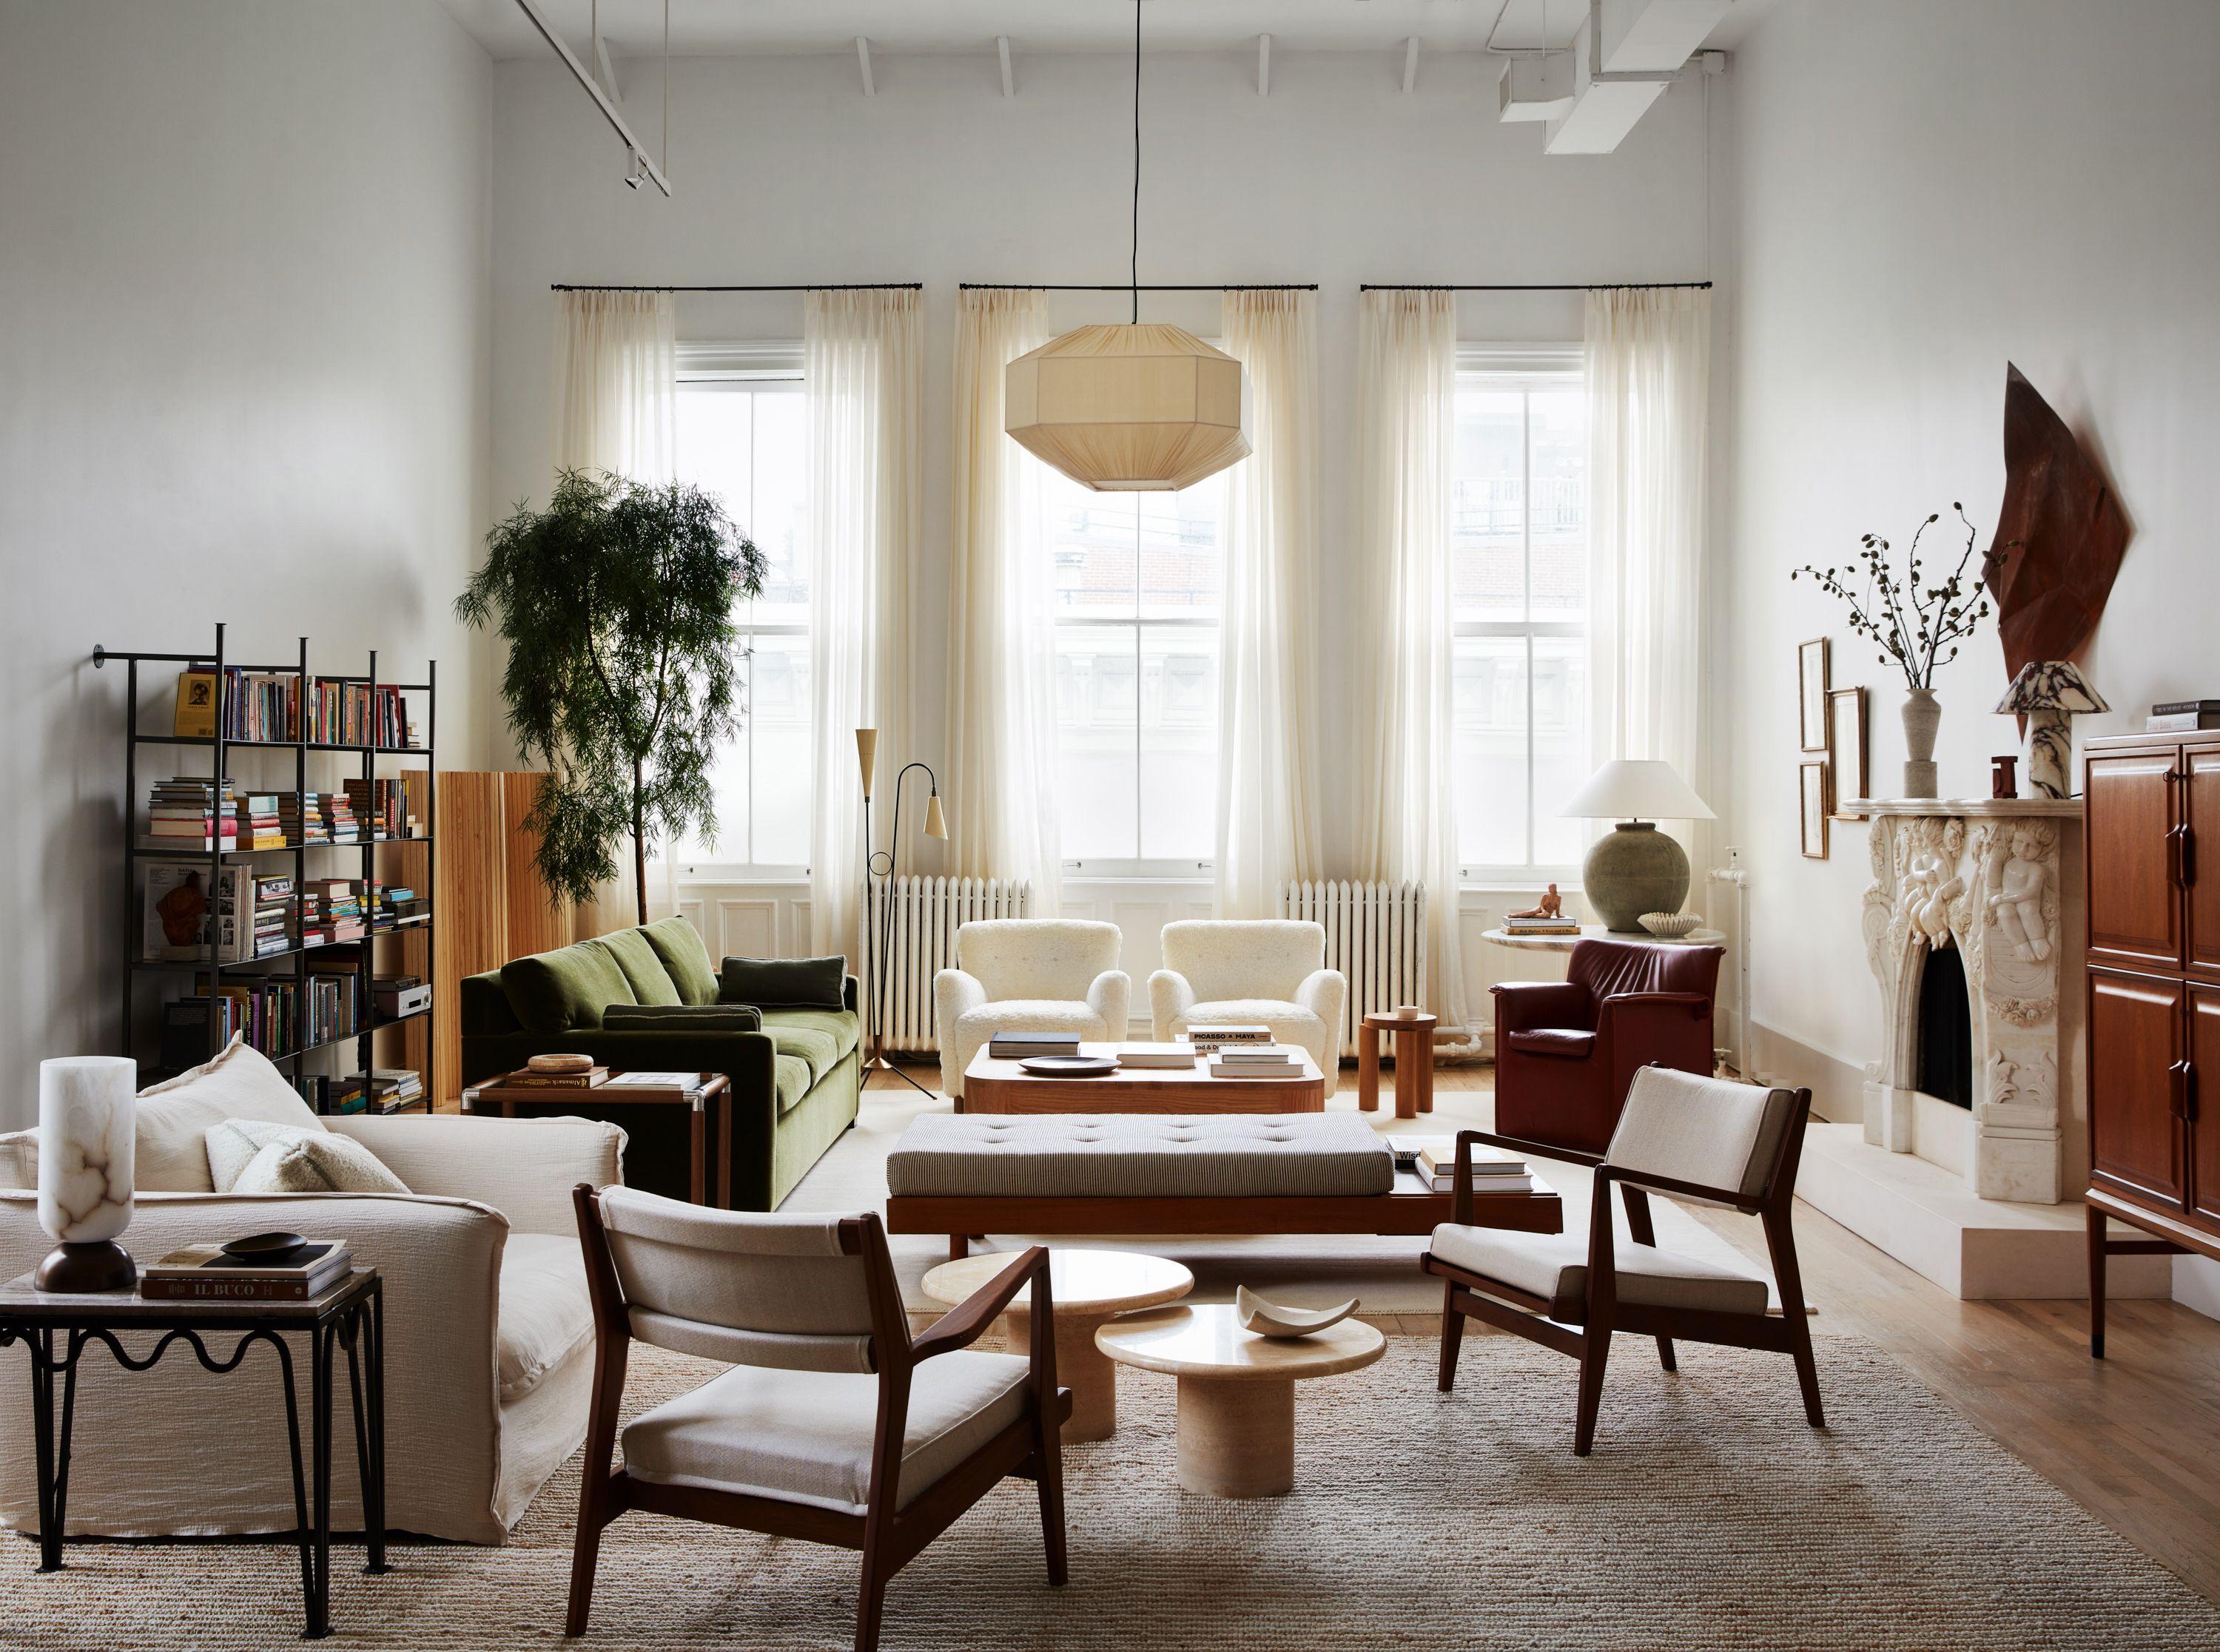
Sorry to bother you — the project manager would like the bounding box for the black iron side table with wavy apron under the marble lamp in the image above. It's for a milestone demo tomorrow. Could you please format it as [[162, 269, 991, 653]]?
[[0, 1268, 386, 1641]]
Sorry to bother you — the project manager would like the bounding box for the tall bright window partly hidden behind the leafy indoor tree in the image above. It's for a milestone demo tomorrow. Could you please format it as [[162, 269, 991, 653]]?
[[677, 351, 810, 873]]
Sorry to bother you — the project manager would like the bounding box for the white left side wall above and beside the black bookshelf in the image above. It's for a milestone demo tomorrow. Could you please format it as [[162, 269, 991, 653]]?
[[0, 0, 493, 1128]]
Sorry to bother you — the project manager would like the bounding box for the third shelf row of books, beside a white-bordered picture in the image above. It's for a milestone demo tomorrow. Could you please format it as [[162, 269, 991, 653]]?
[[140, 862, 431, 964]]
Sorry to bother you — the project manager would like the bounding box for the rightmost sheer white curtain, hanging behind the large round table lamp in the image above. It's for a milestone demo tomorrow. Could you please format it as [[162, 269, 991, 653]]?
[[1585, 286, 1716, 866]]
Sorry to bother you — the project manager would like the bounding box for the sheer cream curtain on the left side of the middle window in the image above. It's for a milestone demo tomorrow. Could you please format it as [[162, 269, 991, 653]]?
[[941, 297, 1061, 917]]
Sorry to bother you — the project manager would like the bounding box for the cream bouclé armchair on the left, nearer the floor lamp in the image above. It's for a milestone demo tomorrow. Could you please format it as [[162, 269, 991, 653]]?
[[932, 917, 1132, 1099]]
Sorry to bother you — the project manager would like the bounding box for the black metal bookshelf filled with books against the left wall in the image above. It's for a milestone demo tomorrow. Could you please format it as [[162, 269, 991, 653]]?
[[93, 624, 437, 1113]]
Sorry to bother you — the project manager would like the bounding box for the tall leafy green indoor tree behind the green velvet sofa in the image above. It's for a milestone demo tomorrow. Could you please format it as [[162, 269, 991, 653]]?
[[455, 471, 766, 924]]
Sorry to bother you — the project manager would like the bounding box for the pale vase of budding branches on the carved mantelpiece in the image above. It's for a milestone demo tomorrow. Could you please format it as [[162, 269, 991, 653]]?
[[1789, 499, 2018, 797]]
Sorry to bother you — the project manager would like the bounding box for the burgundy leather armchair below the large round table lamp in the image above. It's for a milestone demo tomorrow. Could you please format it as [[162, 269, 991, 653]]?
[[1494, 942, 1725, 1153]]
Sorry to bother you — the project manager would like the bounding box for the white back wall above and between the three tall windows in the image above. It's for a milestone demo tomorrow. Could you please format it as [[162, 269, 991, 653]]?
[[493, 51, 1707, 1021]]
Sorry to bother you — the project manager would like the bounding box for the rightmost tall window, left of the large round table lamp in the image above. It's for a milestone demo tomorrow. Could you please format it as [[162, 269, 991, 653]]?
[[1450, 355, 1592, 877]]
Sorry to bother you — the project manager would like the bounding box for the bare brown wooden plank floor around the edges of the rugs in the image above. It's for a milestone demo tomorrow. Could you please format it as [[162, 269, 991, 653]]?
[[872, 1066, 2220, 1603]]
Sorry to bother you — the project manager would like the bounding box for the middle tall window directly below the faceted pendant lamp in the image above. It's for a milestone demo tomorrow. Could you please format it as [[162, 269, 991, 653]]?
[[1048, 471, 1228, 873]]
